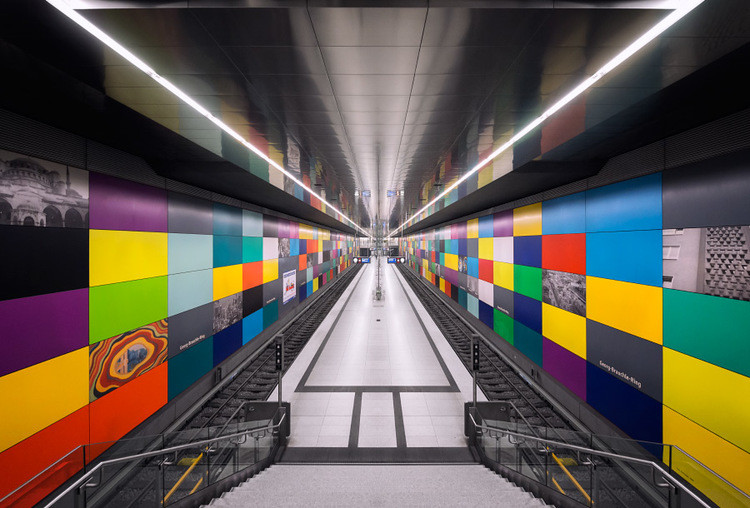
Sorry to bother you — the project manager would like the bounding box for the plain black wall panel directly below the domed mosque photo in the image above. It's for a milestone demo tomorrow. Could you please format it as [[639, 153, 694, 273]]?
[[0, 226, 89, 300]]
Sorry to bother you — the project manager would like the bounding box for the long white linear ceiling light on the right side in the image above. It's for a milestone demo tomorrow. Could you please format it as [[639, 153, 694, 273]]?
[[388, 0, 705, 238]]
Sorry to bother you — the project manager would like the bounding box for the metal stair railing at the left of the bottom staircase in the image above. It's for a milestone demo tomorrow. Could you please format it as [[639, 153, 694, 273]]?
[[44, 408, 287, 508]]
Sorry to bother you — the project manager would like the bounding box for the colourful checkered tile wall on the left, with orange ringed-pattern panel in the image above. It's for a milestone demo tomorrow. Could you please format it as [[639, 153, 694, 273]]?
[[0, 152, 354, 497]]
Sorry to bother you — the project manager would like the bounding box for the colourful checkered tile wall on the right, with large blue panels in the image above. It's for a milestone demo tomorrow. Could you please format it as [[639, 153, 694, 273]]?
[[401, 164, 750, 500]]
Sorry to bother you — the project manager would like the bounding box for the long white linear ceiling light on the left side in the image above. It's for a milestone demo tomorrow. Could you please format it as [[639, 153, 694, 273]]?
[[47, 0, 370, 237]]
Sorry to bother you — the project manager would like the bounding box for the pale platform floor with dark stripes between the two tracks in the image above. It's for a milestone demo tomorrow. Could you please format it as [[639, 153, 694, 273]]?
[[269, 258, 486, 461]]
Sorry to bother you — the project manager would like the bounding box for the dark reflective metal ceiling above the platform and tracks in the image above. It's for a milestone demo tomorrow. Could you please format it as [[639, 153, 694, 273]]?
[[0, 0, 750, 236]]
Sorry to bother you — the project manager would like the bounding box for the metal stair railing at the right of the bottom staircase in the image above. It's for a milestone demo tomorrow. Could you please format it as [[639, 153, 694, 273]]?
[[469, 411, 750, 508]]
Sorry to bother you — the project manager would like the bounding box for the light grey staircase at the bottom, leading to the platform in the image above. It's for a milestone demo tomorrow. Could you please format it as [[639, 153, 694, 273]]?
[[207, 464, 547, 508]]
